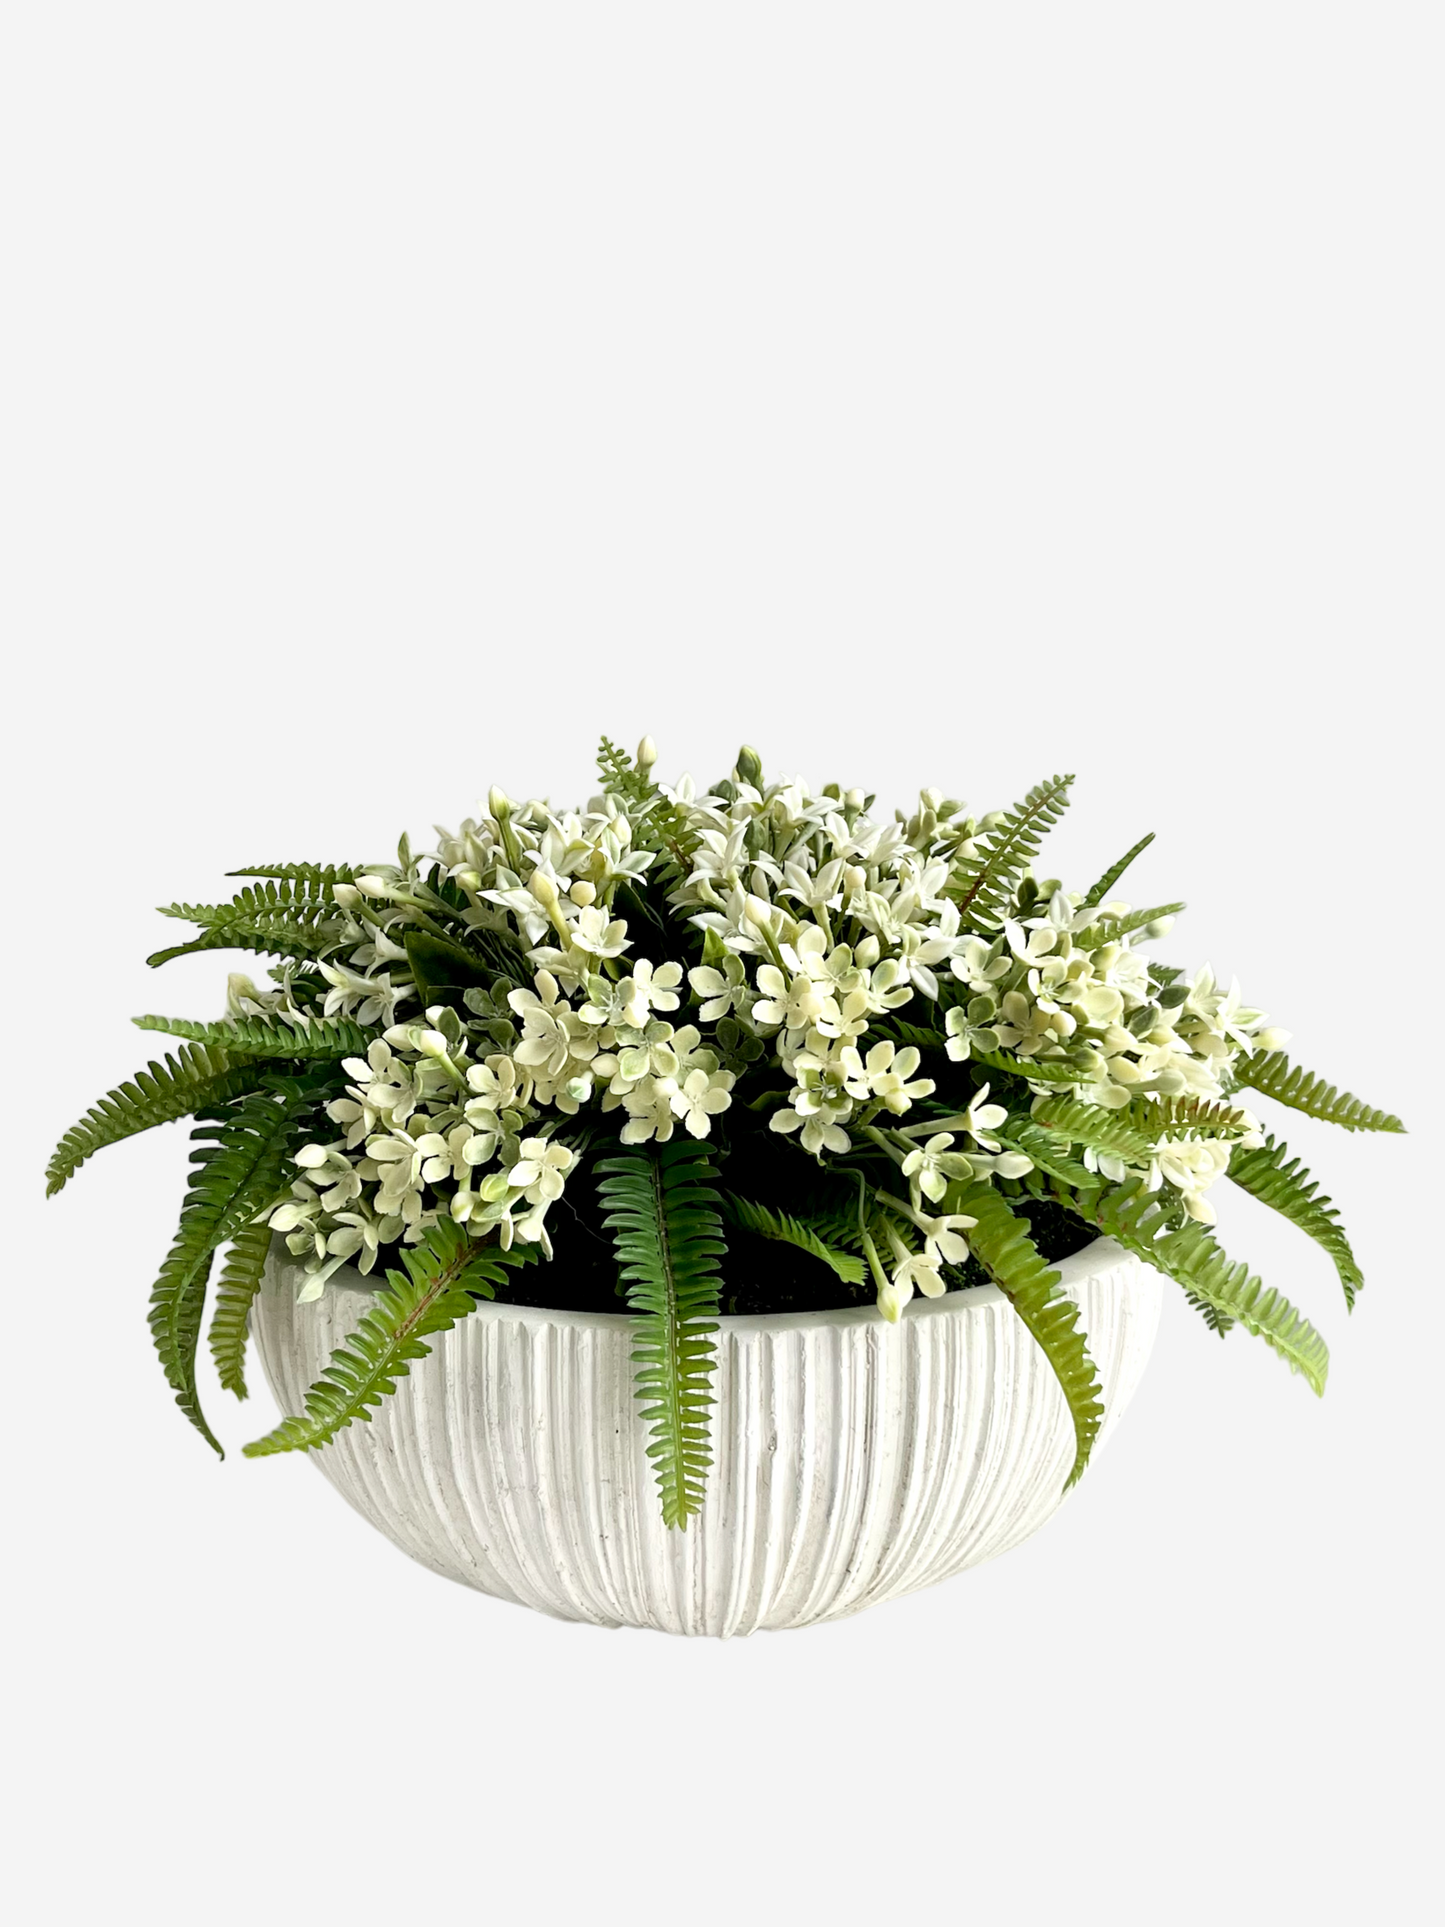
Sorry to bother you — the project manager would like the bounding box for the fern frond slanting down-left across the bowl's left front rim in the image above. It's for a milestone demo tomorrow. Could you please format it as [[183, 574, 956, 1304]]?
[[243, 1218, 522, 1459]]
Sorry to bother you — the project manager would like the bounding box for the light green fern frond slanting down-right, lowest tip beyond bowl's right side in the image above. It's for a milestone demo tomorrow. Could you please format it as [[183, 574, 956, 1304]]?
[[1056, 1179, 1329, 1395]]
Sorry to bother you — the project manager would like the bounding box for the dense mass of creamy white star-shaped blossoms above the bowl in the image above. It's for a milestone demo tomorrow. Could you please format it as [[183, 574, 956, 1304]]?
[[269, 742, 1283, 1316]]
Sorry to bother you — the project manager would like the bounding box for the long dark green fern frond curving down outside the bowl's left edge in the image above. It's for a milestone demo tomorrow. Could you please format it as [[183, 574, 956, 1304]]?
[[150, 1093, 312, 1457]]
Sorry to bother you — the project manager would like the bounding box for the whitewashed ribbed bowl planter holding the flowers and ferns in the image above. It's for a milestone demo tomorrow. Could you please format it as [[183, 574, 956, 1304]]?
[[252, 1239, 1160, 1638]]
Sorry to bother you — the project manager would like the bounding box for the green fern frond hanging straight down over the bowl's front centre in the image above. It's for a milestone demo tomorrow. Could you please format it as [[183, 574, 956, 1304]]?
[[597, 1141, 726, 1530]]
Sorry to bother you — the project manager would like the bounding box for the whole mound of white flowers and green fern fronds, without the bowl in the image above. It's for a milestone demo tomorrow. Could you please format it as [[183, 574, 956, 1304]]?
[[48, 738, 1403, 1526]]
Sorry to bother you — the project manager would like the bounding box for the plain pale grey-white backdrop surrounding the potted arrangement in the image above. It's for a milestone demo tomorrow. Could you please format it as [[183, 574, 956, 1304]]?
[[0, 0, 1445, 1927]]
